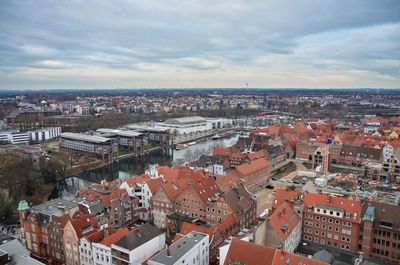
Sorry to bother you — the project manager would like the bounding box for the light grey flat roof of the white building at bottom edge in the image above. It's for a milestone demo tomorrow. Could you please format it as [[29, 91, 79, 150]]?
[[150, 231, 208, 265]]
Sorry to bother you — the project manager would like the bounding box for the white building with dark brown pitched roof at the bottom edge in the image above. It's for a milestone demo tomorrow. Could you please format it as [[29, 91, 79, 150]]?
[[111, 223, 165, 265]]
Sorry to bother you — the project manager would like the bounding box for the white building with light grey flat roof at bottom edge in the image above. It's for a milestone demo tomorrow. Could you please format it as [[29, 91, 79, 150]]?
[[147, 231, 209, 265]]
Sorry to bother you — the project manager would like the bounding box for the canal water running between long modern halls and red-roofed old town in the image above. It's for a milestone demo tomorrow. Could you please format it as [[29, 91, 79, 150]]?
[[49, 135, 239, 199]]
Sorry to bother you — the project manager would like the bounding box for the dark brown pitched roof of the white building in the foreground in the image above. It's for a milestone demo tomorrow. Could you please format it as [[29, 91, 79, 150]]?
[[113, 223, 163, 251]]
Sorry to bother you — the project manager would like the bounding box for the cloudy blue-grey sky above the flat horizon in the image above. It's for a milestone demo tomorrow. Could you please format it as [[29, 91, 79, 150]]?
[[0, 0, 400, 89]]
